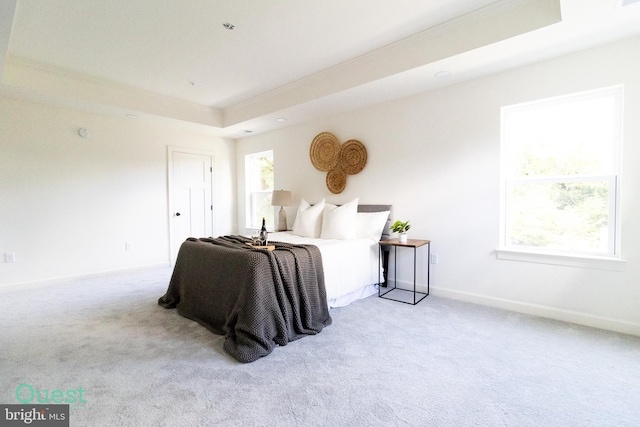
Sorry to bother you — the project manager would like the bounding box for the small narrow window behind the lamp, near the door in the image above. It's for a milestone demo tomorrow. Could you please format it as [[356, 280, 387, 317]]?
[[245, 151, 273, 229]]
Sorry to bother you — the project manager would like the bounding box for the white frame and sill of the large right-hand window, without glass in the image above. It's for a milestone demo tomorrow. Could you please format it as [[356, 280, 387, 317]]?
[[496, 85, 624, 269]]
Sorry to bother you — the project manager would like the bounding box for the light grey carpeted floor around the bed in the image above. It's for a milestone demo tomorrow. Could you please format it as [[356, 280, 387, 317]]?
[[0, 267, 640, 427]]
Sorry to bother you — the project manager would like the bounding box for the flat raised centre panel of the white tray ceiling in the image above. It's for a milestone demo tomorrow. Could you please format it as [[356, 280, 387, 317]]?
[[9, 0, 494, 108]]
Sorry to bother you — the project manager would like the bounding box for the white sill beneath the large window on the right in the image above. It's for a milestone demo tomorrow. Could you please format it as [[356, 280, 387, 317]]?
[[496, 248, 626, 271]]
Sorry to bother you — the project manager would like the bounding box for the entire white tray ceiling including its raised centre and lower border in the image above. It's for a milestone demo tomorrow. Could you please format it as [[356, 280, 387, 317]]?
[[0, 0, 640, 138]]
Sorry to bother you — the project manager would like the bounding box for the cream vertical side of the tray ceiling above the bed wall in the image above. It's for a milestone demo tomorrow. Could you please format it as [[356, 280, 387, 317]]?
[[224, 0, 562, 126]]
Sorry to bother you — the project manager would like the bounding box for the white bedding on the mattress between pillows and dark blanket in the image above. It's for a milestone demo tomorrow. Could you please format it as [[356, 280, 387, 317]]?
[[269, 232, 382, 308]]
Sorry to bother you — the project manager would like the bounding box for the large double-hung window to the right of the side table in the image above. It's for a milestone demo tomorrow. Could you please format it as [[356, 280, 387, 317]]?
[[501, 86, 623, 257]]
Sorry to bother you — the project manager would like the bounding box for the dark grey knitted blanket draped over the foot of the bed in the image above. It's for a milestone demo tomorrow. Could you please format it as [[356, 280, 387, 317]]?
[[158, 236, 331, 362]]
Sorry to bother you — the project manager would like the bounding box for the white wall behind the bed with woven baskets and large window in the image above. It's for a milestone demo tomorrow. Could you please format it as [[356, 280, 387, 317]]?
[[236, 38, 640, 335]]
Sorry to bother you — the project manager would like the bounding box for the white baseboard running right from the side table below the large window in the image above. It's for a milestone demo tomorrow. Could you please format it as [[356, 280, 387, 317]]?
[[430, 286, 640, 336]]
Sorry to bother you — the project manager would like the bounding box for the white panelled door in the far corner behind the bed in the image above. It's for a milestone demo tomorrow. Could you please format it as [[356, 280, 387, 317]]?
[[170, 151, 213, 264]]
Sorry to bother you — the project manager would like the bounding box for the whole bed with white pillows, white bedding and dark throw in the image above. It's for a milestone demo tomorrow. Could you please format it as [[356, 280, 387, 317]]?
[[158, 199, 391, 362]]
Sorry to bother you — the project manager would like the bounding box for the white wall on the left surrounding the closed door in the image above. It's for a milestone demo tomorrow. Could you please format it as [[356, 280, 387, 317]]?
[[0, 98, 236, 286]]
